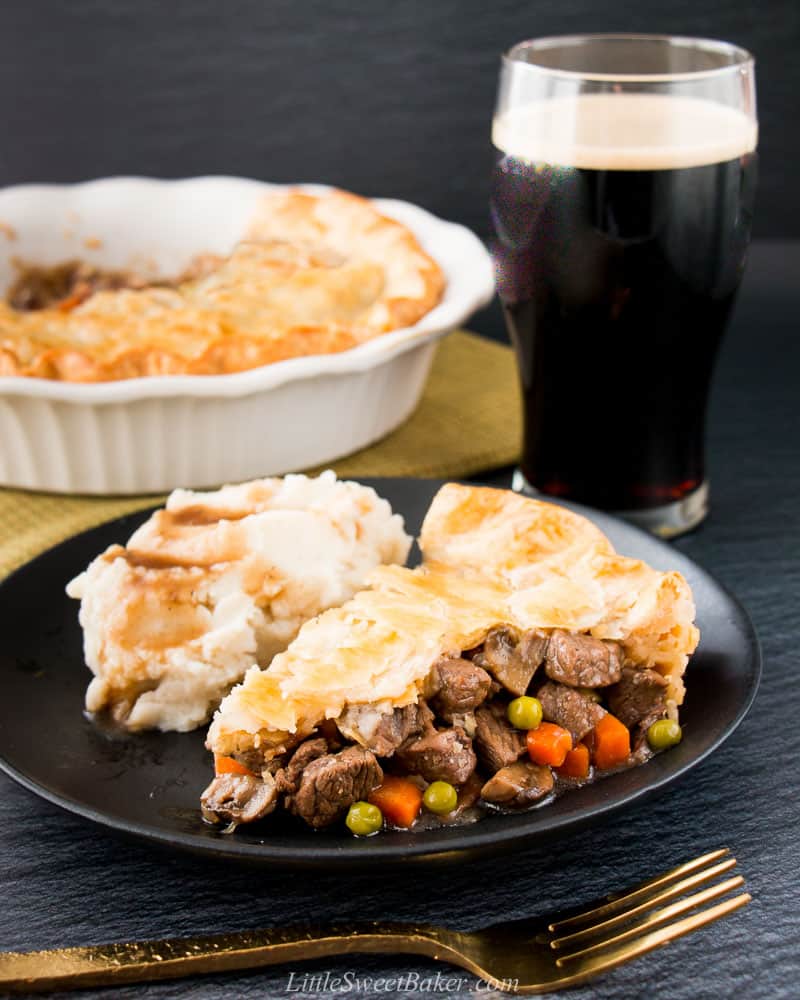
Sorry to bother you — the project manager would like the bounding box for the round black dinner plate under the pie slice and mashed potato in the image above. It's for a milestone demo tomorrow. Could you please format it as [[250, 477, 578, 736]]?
[[0, 479, 761, 867]]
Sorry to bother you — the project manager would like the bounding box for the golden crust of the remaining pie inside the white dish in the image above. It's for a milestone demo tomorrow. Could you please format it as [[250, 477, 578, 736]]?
[[0, 189, 445, 382]]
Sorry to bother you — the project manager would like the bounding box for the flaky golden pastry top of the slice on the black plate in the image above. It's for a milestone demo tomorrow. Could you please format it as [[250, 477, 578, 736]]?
[[208, 484, 699, 757]]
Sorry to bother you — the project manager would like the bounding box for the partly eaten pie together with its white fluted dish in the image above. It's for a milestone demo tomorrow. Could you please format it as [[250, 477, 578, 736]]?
[[0, 177, 494, 495]]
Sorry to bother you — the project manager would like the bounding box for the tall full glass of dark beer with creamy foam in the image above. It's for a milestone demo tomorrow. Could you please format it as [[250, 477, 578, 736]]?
[[491, 35, 757, 536]]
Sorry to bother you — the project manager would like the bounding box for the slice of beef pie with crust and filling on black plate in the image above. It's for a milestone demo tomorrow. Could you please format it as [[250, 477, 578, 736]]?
[[201, 484, 699, 835]]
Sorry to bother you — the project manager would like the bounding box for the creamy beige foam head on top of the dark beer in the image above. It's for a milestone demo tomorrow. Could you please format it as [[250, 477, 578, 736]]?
[[492, 93, 758, 170]]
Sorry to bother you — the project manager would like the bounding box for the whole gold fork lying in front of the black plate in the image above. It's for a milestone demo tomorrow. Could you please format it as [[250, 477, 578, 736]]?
[[0, 849, 751, 993]]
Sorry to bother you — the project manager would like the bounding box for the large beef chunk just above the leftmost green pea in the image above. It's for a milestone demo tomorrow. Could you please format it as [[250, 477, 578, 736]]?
[[286, 747, 383, 827]]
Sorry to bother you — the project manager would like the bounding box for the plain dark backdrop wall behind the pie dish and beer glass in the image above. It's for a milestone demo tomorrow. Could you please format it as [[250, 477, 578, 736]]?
[[0, 0, 800, 244]]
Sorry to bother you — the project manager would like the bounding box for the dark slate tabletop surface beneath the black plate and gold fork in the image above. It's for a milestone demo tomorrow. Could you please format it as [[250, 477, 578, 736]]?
[[0, 243, 800, 1000]]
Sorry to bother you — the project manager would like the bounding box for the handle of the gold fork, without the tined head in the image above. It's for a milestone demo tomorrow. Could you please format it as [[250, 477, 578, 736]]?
[[0, 921, 455, 993]]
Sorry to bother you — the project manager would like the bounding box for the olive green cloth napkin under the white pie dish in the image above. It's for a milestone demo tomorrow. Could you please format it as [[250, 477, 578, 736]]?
[[0, 331, 520, 577]]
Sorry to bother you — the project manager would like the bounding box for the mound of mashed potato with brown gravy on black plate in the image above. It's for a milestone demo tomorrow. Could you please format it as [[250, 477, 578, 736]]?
[[67, 472, 411, 732]]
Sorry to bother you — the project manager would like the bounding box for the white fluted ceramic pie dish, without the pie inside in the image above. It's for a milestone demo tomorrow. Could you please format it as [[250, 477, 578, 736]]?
[[0, 177, 494, 494]]
